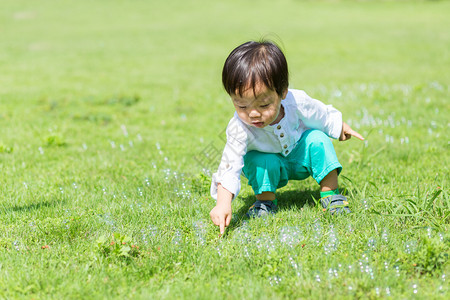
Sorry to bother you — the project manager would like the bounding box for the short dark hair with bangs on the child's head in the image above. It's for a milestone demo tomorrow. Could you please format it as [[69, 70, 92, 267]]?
[[222, 40, 289, 96]]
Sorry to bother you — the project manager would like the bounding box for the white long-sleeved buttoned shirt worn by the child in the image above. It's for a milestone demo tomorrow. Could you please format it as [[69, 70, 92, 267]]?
[[211, 89, 342, 199]]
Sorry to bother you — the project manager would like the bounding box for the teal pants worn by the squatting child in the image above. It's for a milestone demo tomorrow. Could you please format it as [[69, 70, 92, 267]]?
[[242, 129, 342, 195]]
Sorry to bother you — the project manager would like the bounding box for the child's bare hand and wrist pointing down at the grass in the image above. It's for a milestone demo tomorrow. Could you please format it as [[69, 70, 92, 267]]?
[[209, 183, 233, 235]]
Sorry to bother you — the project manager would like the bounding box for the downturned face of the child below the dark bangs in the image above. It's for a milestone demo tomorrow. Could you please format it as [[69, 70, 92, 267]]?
[[231, 83, 287, 128]]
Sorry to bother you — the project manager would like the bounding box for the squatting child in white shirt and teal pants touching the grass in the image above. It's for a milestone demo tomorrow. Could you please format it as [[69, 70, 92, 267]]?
[[210, 41, 364, 234]]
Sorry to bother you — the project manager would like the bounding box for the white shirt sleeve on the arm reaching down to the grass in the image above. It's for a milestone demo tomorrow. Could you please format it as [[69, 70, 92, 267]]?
[[211, 119, 248, 200]]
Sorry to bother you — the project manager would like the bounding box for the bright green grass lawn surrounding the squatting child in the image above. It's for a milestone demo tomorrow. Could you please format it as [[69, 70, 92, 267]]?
[[0, 0, 450, 299]]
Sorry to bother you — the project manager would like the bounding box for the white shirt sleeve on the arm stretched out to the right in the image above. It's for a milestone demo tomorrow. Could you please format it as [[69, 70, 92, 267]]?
[[296, 91, 342, 139]]
